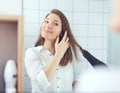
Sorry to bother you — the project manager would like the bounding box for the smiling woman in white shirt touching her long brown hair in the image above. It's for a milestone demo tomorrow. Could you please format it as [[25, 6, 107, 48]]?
[[25, 9, 93, 93]]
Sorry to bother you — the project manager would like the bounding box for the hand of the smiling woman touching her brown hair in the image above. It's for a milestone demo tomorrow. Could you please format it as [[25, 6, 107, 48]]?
[[55, 31, 70, 59]]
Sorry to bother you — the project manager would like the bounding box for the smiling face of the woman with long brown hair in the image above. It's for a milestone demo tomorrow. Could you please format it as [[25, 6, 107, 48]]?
[[41, 14, 62, 41]]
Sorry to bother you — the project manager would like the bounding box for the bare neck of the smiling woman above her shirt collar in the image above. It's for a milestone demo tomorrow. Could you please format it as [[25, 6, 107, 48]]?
[[43, 41, 55, 55]]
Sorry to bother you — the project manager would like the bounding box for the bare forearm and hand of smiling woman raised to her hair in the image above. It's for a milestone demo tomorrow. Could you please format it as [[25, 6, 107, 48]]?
[[44, 31, 69, 81]]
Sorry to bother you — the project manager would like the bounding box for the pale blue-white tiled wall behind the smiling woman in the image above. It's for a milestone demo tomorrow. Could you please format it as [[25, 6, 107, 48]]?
[[23, 0, 109, 91]]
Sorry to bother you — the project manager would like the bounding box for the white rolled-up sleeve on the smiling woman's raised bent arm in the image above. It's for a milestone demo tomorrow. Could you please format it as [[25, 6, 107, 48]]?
[[25, 48, 50, 90]]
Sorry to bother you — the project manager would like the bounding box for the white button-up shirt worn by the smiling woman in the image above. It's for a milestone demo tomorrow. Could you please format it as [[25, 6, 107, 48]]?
[[25, 46, 94, 93]]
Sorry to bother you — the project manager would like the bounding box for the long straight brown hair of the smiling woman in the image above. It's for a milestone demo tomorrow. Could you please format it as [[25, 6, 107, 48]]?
[[35, 9, 82, 66]]
